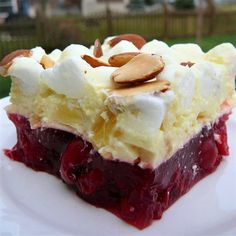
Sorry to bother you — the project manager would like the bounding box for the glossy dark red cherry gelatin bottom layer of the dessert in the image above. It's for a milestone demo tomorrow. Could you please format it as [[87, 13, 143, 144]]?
[[5, 114, 228, 229]]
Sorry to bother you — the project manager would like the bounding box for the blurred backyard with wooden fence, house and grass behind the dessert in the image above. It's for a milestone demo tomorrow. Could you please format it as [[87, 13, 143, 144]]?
[[0, 0, 236, 98]]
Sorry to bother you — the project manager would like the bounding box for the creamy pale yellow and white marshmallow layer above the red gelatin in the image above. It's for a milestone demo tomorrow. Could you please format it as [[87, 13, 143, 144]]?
[[3, 37, 236, 167]]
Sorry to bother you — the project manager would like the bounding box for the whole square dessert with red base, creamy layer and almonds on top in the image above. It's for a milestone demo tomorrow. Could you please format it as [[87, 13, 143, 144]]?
[[0, 34, 236, 229]]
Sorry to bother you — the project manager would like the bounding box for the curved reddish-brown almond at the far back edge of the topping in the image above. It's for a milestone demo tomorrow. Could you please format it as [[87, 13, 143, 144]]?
[[108, 34, 146, 49]]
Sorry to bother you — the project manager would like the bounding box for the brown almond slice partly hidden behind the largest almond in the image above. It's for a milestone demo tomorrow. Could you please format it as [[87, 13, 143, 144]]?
[[108, 52, 140, 67]]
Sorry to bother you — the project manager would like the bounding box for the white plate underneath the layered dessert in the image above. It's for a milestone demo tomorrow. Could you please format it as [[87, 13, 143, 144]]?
[[0, 98, 236, 236]]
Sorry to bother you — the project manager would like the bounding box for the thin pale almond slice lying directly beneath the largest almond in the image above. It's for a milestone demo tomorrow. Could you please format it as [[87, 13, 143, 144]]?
[[111, 80, 170, 96]]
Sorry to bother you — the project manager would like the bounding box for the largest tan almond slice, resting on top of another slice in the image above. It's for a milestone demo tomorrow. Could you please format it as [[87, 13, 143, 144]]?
[[111, 54, 165, 84]]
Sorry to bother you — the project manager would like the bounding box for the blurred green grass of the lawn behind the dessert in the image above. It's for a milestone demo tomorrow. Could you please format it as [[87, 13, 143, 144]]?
[[0, 33, 236, 98]]
